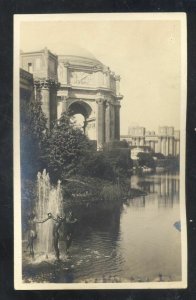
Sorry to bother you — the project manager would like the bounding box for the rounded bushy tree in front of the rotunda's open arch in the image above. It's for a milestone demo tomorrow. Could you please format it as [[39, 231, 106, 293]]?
[[45, 113, 91, 179]]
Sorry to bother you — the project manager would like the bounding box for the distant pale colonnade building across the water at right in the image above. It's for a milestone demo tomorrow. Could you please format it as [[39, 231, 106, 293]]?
[[121, 126, 180, 156]]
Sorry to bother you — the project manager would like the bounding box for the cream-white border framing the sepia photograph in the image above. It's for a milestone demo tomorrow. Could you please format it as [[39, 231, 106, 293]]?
[[13, 13, 187, 290]]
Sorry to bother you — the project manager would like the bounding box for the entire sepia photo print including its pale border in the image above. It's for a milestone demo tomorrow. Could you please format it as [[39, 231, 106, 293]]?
[[14, 13, 187, 290]]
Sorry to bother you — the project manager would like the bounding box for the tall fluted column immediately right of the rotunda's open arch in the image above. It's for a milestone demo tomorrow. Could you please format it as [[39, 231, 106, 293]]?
[[96, 98, 105, 150]]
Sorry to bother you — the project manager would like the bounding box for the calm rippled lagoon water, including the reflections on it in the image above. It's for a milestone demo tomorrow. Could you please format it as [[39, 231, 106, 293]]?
[[24, 174, 181, 282]]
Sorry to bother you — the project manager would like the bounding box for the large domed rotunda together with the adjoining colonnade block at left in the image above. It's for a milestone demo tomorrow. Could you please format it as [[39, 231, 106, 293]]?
[[21, 48, 123, 149]]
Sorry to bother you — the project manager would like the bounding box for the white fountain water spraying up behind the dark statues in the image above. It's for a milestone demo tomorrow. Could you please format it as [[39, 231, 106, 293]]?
[[36, 169, 63, 255]]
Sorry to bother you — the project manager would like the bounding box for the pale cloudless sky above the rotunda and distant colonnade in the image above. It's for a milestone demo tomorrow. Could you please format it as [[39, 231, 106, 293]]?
[[20, 18, 181, 134]]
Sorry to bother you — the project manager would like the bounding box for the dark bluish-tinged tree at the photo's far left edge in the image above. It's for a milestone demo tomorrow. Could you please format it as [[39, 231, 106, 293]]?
[[20, 100, 47, 178]]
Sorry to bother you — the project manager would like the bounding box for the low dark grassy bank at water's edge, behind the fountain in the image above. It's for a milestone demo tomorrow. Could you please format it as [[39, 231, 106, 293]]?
[[22, 176, 144, 220]]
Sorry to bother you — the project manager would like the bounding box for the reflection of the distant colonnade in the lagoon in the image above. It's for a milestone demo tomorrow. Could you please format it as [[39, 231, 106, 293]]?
[[130, 173, 180, 208]]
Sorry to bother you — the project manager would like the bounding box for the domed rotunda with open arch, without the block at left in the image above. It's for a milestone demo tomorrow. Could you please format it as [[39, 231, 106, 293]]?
[[58, 48, 122, 149]]
